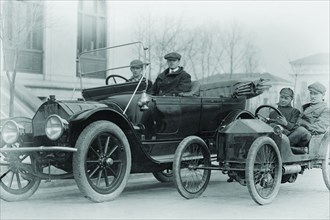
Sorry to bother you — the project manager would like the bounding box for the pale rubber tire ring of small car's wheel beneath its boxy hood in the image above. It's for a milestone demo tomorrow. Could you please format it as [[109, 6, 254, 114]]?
[[245, 136, 282, 205]]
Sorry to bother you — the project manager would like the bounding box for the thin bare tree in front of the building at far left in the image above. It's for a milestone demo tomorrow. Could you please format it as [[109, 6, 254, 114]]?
[[0, 1, 44, 116]]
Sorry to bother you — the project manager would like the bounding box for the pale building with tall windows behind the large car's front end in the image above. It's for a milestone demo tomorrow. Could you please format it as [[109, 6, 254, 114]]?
[[0, 1, 110, 116]]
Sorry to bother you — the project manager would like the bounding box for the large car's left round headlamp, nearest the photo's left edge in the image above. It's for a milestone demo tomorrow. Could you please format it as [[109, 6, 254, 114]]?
[[1, 120, 24, 144]]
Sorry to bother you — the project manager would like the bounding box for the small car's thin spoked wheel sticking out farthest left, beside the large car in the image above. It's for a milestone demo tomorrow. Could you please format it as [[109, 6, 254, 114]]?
[[173, 136, 211, 199]]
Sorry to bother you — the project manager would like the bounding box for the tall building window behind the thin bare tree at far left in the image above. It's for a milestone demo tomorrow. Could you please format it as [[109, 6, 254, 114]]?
[[3, 1, 44, 73]]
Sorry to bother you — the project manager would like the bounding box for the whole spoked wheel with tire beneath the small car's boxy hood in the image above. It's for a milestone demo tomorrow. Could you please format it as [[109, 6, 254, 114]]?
[[245, 137, 282, 205]]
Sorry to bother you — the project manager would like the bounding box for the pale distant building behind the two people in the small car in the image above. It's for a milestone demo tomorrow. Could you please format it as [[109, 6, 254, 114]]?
[[290, 53, 330, 106]]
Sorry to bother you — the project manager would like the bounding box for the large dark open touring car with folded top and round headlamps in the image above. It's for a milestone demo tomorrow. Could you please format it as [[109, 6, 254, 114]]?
[[0, 41, 278, 202]]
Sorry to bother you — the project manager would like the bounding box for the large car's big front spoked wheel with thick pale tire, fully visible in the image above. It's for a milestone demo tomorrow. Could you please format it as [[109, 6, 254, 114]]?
[[73, 121, 132, 202]]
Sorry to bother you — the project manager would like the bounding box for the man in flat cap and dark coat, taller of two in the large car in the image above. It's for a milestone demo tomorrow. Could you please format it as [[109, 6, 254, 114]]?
[[152, 52, 191, 96]]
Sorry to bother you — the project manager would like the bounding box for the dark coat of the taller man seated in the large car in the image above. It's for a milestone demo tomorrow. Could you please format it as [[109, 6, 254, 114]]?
[[152, 67, 191, 96]]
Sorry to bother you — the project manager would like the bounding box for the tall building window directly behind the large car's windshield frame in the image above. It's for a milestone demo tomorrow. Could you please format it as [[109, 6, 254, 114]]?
[[77, 0, 107, 78]]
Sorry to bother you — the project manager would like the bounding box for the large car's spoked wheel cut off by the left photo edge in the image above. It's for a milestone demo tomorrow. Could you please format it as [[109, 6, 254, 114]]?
[[0, 145, 41, 202]]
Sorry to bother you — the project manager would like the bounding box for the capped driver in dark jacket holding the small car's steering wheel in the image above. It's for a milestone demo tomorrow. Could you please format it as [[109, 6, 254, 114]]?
[[269, 88, 300, 135]]
